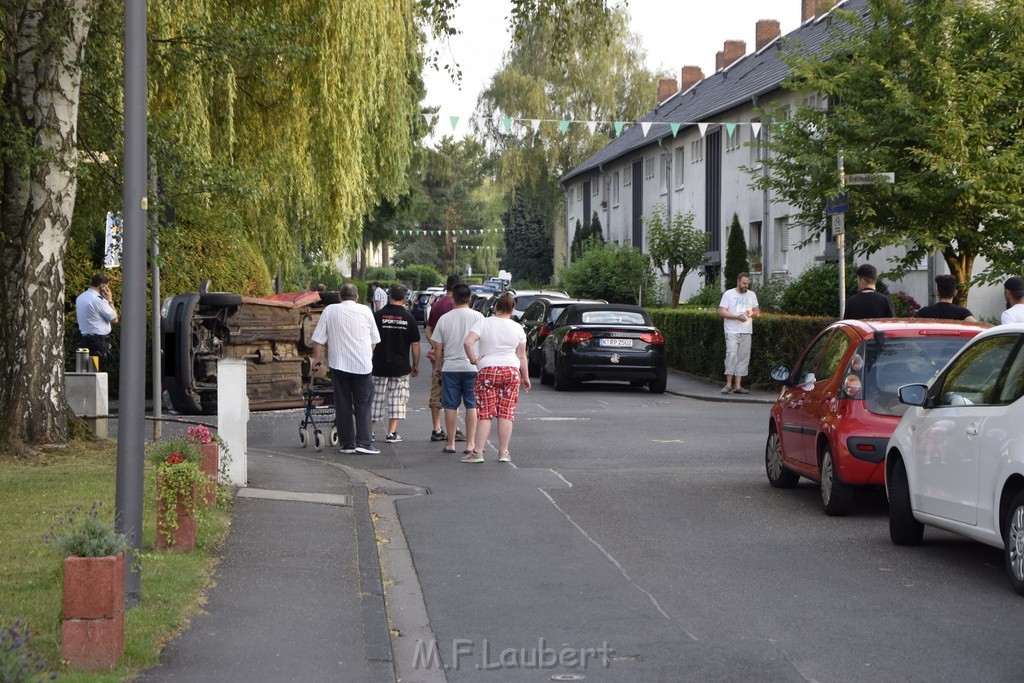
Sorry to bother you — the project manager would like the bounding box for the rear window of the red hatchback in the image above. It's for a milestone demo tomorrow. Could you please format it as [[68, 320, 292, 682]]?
[[861, 337, 967, 416]]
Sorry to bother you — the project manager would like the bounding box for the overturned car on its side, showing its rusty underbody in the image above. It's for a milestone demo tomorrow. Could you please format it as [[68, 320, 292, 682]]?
[[161, 284, 339, 415]]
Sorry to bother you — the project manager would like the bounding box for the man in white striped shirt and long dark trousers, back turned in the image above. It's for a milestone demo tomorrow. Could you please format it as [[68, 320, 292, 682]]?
[[311, 283, 381, 455]]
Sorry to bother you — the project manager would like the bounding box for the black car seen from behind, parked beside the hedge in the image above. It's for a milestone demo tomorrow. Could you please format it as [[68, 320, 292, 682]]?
[[540, 303, 668, 393]]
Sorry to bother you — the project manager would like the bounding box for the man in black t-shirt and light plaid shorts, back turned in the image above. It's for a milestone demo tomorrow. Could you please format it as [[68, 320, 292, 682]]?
[[370, 285, 420, 443]]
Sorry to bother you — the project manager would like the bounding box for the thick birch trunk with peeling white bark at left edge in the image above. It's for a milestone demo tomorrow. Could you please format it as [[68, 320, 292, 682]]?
[[0, 0, 94, 453]]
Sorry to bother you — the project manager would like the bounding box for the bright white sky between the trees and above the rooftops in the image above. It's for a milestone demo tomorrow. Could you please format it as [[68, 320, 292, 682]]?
[[423, 0, 801, 137]]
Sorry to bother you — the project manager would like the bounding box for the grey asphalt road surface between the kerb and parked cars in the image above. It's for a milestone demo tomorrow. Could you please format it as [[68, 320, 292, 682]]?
[[344, 358, 1024, 681]]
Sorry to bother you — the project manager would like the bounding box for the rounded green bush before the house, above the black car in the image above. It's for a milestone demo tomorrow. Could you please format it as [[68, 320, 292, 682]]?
[[559, 241, 655, 304]]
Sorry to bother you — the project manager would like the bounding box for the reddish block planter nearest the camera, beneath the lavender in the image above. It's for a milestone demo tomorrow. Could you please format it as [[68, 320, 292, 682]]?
[[60, 553, 125, 671]]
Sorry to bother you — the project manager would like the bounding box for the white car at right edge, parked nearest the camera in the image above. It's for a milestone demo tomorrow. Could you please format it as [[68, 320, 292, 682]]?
[[886, 324, 1024, 595]]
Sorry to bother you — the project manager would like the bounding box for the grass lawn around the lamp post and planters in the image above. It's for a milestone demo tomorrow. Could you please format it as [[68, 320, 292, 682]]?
[[0, 440, 230, 683]]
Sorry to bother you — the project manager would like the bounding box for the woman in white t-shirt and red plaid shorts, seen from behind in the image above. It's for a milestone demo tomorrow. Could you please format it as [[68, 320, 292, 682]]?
[[462, 292, 530, 463]]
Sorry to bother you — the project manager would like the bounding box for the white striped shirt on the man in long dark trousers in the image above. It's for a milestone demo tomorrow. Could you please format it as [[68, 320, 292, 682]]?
[[310, 300, 381, 375]]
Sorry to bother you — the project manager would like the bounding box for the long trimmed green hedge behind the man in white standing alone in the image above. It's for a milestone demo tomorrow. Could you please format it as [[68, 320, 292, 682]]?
[[649, 308, 836, 389]]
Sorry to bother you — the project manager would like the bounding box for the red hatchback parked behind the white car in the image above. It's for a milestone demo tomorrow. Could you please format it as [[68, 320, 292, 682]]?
[[765, 319, 988, 515]]
